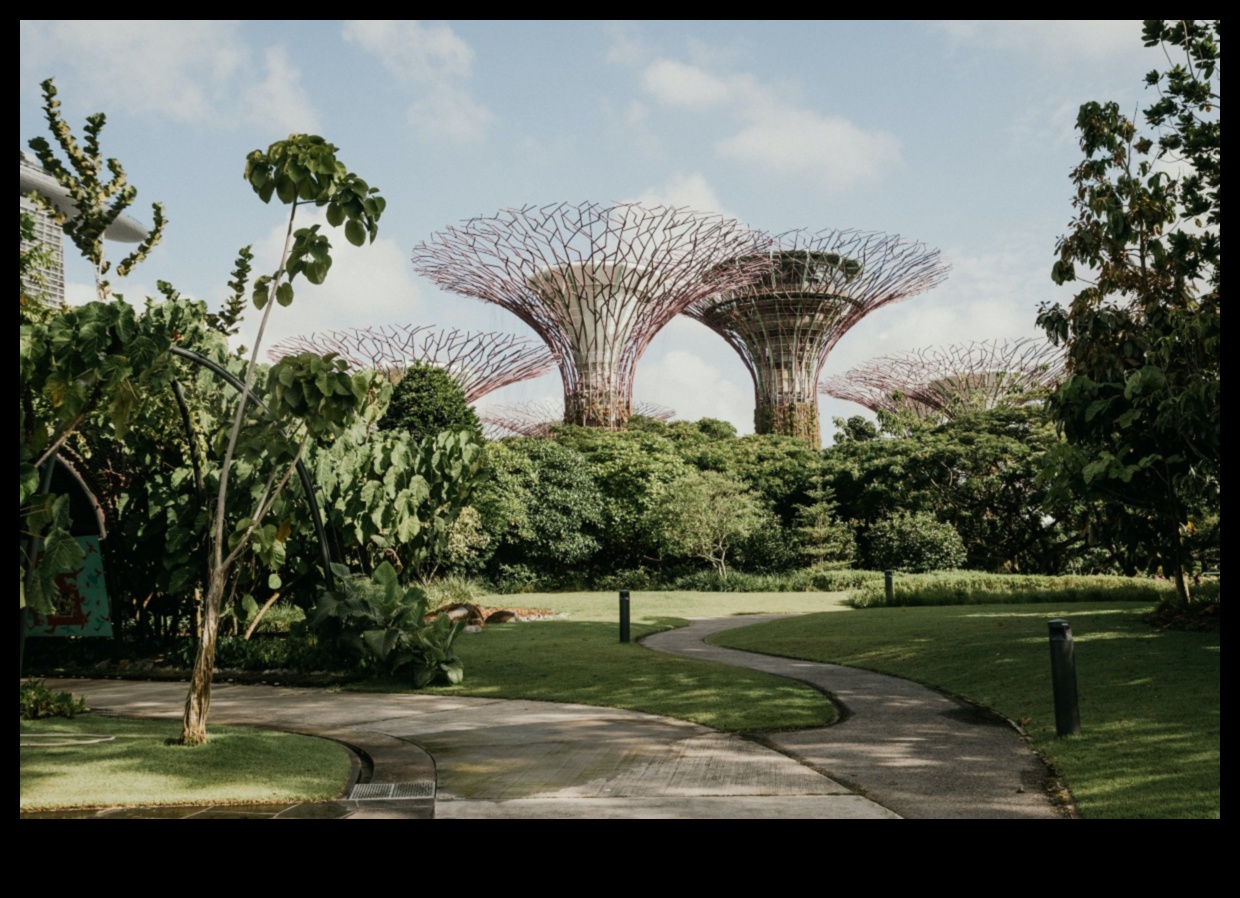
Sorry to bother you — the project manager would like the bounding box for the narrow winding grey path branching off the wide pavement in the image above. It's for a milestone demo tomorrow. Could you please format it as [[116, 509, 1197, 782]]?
[[642, 615, 1065, 819]]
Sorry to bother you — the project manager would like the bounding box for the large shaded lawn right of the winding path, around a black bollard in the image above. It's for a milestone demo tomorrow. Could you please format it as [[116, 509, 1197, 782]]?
[[713, 603, 1221, 817]]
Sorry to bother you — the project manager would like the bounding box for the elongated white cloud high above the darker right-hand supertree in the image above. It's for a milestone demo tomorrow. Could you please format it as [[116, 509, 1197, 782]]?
[[641, 60, 900, 190]]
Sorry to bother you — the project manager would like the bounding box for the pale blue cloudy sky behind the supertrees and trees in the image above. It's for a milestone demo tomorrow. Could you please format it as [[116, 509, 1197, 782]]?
[[20, 20, 1166, 443]]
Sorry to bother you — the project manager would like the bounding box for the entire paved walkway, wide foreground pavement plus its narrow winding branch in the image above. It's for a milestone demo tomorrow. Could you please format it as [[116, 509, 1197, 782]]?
[[19, 616, 1058, 819]]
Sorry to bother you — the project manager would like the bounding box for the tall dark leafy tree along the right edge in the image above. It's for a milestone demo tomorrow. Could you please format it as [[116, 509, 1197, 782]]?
[[1038, 20, 1221, 602]]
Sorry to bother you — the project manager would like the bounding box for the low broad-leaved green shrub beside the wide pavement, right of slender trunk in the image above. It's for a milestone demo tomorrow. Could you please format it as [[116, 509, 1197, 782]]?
[[310, 562, 465, 687]]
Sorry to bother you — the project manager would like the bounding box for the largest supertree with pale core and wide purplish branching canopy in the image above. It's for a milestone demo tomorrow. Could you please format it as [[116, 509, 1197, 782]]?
[[413, 203, 769, 428]]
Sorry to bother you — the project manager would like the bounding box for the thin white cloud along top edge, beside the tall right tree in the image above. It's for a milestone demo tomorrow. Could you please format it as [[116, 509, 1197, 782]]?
[[930, 19, 1141, 60]]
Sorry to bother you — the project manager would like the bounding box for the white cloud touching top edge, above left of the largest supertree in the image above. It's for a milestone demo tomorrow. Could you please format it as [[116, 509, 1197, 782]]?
[[342, 20, 495, 140]]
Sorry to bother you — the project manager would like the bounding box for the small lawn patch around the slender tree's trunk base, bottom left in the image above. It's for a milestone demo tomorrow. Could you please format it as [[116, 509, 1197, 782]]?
[[19, 714, 350, 811]]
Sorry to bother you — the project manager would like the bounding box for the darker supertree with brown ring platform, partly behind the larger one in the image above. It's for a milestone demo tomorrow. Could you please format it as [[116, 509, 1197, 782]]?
[[686, 229, 949, 445]]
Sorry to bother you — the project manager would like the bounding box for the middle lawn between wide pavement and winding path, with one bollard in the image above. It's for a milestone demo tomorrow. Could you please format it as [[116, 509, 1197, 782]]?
[[355, 592, 844, 732]]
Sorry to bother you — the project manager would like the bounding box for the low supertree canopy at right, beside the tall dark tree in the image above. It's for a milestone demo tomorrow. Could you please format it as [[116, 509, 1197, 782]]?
[[822, 339, 1064, 419]]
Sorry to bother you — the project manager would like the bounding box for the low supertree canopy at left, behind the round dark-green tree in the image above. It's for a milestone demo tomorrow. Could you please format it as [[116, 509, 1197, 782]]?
[[268, 324, 556, 402]]
